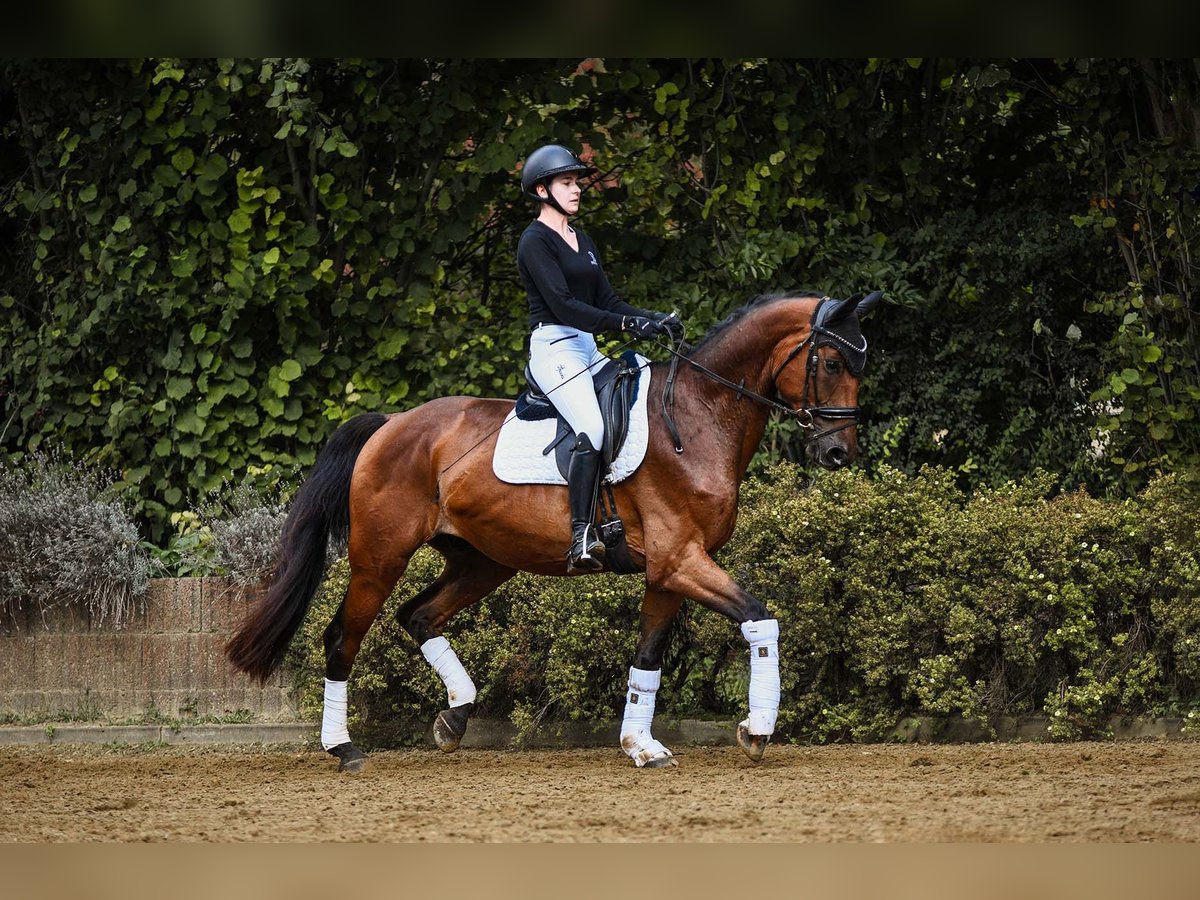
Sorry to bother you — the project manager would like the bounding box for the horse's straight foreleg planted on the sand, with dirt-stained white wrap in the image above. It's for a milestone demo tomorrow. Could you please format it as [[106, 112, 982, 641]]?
[[620, 588, 683, 769]]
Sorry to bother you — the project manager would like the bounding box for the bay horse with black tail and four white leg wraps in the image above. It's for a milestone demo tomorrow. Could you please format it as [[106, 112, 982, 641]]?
[[227, 292, 880, 772]]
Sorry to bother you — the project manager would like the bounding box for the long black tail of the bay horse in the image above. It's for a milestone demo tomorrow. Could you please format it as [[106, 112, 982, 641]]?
[[226, 413, 388, 682]]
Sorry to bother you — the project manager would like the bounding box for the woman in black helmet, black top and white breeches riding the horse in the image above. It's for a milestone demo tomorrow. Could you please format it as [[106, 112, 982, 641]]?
[[517, 144, 683, 571]]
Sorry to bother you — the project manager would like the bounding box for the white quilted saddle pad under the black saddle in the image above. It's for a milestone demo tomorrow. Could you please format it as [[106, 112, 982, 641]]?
[[492, 355, 650, 485]]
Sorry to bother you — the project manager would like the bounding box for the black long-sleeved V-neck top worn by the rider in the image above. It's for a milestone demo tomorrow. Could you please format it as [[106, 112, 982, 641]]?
[[517, 220, 652, 334]]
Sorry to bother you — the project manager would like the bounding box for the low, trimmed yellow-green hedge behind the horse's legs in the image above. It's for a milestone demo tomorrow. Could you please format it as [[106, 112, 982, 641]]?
[[288, 463, 1200, 743]]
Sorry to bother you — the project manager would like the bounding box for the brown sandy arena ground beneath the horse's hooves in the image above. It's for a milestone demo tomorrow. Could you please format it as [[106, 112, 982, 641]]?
[[0, 740, 1200, 841]]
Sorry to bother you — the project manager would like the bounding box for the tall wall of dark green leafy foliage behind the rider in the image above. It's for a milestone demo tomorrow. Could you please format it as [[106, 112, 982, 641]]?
[[0, 59, 1200, 541]]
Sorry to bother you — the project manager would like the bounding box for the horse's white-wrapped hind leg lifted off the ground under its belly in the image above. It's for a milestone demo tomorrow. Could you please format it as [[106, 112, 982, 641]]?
[[396, 536, 515, 754]]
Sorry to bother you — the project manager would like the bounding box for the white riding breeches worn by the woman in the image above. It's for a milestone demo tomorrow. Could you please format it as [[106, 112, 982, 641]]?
[[529, 325, 608, 450]]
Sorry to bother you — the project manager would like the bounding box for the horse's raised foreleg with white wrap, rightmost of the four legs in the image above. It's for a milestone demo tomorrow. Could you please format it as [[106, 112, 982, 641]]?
[[647, 547, 780, 762]]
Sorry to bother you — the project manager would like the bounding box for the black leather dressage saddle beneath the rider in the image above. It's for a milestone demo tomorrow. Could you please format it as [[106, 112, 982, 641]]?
[[516, 350, 641, 480]]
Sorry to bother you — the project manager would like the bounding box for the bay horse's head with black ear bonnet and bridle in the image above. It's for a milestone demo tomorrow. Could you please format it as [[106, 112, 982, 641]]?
[[774, 290, 883, 469]]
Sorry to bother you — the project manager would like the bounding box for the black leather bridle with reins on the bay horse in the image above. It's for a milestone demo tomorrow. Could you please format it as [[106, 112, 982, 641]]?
[[660, 296, 866, 454]]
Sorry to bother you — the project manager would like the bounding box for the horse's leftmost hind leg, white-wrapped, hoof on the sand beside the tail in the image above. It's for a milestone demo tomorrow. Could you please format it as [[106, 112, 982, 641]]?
[[320, 559, 408, 772]]
